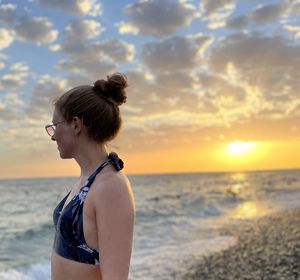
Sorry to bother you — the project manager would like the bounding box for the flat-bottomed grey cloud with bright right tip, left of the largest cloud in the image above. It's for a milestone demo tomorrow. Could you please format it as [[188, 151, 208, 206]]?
[[141, 34, 212, 73]]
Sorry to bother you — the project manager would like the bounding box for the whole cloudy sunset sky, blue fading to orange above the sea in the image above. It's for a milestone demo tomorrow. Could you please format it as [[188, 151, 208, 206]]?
[[0, 0, 300, 178]]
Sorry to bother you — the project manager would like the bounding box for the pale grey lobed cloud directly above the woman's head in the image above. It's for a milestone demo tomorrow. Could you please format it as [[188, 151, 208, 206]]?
[[51, 20, 135, 79]]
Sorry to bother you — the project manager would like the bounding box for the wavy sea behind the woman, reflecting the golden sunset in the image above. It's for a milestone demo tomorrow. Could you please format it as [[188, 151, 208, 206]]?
[[0, 170, 300, 280]]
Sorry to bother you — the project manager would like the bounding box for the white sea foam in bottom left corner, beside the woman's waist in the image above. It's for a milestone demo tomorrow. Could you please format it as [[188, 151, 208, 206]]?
[[0, 263, 51, 280]]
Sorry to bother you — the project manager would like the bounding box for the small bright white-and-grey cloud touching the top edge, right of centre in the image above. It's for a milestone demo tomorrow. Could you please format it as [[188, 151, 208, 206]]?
[[200, 0, 236, 29]]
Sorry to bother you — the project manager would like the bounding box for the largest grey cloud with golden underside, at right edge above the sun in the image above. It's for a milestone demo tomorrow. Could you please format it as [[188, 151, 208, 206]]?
[[210, 34, 300, 118]]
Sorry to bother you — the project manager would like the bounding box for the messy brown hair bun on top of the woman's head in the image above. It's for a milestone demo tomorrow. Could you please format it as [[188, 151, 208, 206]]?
[[94, 73, 128, 106]]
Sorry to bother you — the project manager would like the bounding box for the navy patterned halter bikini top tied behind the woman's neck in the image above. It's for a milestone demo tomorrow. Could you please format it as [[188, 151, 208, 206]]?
[[53, 153, 123, 265]]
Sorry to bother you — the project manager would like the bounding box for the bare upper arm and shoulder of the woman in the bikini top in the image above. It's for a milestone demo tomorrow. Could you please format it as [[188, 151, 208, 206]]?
[[94, 177, 135, 280]]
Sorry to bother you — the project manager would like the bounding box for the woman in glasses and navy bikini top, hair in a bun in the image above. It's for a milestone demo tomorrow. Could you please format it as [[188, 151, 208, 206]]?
[[45, 73, 135, 280]]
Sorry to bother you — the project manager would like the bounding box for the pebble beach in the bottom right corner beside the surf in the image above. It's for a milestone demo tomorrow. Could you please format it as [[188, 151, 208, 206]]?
[[184, 208, 300, 280]]
